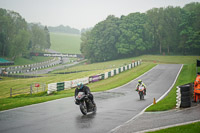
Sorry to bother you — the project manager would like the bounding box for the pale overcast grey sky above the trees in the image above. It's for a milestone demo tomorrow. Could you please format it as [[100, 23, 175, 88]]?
[[0, 0, 200, 30]]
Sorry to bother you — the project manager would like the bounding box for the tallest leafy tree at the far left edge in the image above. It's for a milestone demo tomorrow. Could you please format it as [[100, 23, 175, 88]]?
[[0, 9, 29, 60]]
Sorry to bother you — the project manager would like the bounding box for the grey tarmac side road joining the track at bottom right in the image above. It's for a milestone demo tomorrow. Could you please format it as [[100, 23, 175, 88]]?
[[113, 104, 200, 133]]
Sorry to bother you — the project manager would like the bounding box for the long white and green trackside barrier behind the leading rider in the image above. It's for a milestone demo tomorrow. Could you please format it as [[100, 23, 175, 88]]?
[[47, 61, 141, 94]]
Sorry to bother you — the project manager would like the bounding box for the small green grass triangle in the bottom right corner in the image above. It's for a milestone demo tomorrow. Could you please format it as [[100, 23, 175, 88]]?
[[148, 122, 200, 133]]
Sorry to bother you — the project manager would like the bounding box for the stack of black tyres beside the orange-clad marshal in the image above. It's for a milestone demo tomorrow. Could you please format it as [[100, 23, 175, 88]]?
[[180, 84, 191, 108]]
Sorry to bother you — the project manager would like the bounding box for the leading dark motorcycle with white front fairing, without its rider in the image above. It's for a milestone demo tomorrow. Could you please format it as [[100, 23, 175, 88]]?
[[76, 92, 97, 115]]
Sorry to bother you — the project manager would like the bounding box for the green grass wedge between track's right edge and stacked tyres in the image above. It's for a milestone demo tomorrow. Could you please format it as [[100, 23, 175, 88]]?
[[146, 64, 196, 112]]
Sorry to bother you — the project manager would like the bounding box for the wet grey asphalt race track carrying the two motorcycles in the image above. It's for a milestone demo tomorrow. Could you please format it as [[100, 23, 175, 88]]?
[[0, 64, 181, 133]]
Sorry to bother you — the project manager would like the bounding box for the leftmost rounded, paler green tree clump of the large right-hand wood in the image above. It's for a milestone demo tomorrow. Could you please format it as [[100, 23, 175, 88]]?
[[81, 16, 120, 62]]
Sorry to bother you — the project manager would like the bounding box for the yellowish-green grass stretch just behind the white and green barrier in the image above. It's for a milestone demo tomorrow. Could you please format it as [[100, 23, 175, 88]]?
[[0, 58, 141, 98]]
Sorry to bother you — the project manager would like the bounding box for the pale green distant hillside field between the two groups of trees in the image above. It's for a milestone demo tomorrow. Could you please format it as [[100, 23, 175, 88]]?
[[50, 32, 81, 54]]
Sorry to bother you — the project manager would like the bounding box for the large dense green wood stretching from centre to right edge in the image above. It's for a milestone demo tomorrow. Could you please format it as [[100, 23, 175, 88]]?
[[81, 2, 200, 62]]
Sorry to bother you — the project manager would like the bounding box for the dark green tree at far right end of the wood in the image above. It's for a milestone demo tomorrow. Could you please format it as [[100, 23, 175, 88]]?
[[179, 3, 200, 54]]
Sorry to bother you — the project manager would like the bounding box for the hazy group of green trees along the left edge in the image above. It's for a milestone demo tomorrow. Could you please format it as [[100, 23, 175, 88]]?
[[0, 8, 51, 60]]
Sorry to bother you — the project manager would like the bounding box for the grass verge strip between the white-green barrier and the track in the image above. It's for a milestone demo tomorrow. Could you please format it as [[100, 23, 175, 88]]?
[[0, 63, 155, 111]]
